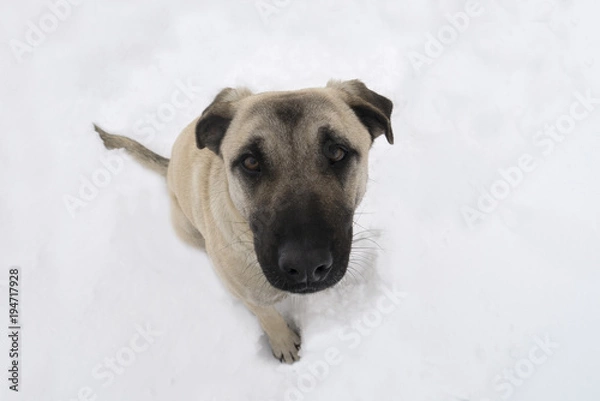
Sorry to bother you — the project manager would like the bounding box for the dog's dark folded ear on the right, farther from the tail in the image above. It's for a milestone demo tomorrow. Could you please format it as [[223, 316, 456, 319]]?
[[327, 79, 394, 144]]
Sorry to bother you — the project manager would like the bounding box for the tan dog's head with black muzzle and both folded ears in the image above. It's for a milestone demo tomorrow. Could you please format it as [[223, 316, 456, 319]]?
[[196, 81, 393, 293]]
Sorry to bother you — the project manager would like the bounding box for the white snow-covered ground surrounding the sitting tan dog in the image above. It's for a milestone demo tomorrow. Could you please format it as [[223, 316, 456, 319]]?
[[0, 0, 600, 401]]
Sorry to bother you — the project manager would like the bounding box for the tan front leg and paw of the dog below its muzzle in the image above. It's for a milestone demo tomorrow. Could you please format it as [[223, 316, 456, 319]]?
[[246, 303, 300, 363]]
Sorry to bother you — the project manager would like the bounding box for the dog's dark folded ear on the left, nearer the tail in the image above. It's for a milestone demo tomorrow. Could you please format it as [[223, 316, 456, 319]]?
[[196, 88, 252, 155]]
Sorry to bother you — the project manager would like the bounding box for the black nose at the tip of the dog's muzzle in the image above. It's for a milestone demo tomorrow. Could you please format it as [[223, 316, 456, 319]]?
[[279, 244, 333, 284]]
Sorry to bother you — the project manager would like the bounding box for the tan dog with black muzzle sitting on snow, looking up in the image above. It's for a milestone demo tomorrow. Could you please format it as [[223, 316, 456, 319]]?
[[94, 80, 394, 363]]
